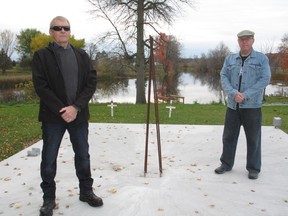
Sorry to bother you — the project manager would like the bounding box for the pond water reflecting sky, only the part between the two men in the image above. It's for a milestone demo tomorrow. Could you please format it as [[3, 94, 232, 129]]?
[[92, 73, 221, 104]]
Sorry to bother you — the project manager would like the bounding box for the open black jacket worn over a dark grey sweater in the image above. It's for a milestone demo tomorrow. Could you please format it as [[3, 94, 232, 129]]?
[[32, 43, 97, 123]]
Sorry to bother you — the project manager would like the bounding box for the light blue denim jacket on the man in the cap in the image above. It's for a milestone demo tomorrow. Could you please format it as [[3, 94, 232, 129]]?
[[220, 49, 271, 110]]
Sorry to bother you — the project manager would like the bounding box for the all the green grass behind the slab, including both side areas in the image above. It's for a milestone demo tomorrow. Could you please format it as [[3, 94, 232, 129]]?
[[0, 99, 288, 161]]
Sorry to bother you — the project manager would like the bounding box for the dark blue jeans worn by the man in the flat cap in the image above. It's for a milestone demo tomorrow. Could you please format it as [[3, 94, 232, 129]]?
[[220, 108, 262, 172]]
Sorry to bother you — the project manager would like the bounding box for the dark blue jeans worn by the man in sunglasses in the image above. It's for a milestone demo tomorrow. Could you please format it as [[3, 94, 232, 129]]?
[[41, 122, 93, 199]]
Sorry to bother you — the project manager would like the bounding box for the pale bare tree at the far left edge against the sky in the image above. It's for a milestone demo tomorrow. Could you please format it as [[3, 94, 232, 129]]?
[[0, 30, 16, 58]]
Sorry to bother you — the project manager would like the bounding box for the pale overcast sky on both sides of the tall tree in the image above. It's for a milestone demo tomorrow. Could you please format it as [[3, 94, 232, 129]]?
[[0, 0, 288, 57]]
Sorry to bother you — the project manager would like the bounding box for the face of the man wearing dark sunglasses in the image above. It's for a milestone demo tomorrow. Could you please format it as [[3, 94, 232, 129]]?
[[49, 20, 71, 47]]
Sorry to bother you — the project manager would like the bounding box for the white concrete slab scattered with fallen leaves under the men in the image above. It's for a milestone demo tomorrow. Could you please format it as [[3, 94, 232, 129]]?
[[0, 123, 288, 216]]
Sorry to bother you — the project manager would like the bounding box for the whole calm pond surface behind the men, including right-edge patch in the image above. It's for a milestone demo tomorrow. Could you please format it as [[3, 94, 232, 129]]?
[[93, 73, 288, 104]]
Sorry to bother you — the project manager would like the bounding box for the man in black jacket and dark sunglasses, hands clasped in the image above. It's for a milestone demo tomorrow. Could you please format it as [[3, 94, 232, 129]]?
[[32, 16, 103, 216]]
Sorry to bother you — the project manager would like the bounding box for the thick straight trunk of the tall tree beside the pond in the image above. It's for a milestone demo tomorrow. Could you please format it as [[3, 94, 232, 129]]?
[[136, 0, 146, 104]]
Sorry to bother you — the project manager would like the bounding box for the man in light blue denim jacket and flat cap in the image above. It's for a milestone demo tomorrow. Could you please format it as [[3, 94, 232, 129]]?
[[215, 30, 271, 179]]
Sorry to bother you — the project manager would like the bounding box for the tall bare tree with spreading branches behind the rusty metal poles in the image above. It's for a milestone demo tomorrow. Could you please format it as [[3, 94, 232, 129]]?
[[88, 0, 193, 104]]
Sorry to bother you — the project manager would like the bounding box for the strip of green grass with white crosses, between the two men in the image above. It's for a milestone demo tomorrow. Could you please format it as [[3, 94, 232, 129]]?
[[90, 103, 226, 125]]
